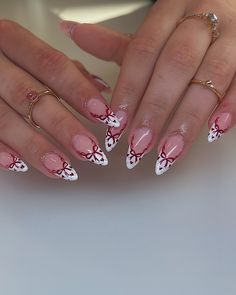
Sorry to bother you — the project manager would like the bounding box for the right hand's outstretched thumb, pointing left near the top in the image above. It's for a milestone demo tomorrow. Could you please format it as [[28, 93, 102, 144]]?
[[60, 21, 130, 65]]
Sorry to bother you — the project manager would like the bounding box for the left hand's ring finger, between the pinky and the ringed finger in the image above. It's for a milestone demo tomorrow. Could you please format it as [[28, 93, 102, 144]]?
[[0, 98, 78, 181]]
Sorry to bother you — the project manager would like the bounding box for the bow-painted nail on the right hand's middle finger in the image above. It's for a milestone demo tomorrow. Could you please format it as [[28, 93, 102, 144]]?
[[126, 127, 152, 169]]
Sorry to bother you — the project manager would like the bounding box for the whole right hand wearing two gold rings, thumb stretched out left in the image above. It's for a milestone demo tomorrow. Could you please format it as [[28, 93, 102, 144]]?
[[62, 0, 236, 175]]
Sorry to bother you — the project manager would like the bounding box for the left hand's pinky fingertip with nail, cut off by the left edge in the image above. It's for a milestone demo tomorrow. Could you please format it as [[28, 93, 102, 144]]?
[[0, 142, 28, 172]]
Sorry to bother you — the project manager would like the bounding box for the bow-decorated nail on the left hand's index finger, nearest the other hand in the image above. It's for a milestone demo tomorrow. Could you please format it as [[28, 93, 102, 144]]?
[[87, 98, 120, 127]]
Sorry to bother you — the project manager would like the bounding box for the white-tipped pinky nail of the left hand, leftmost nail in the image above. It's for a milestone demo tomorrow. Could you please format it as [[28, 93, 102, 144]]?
[[0, 152, 29, 172]]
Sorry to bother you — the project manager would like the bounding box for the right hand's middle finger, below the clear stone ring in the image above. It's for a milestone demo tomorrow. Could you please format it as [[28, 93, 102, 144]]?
[[126, 8, 211, 169]]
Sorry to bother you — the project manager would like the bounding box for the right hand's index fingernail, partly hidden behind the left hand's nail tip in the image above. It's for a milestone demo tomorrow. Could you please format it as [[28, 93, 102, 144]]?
[[105, 110, 128, 152]]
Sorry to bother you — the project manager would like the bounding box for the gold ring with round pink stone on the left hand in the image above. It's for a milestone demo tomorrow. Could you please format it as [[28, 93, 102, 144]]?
[[27, 87, 61, 129]]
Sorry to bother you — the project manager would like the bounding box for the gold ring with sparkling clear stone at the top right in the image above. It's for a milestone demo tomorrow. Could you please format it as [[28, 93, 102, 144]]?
[[177, 12, 220, 43]]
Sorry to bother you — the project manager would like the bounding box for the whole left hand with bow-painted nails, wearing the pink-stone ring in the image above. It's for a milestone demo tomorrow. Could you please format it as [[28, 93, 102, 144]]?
[[0, 20, 119, 181]]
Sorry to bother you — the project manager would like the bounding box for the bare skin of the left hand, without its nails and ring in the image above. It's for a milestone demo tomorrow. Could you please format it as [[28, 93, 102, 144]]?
[[0, 20, 114, 178]]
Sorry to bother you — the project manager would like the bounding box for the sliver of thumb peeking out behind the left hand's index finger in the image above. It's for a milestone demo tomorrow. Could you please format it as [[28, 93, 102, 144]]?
[[72, 60, 111, 93]]
